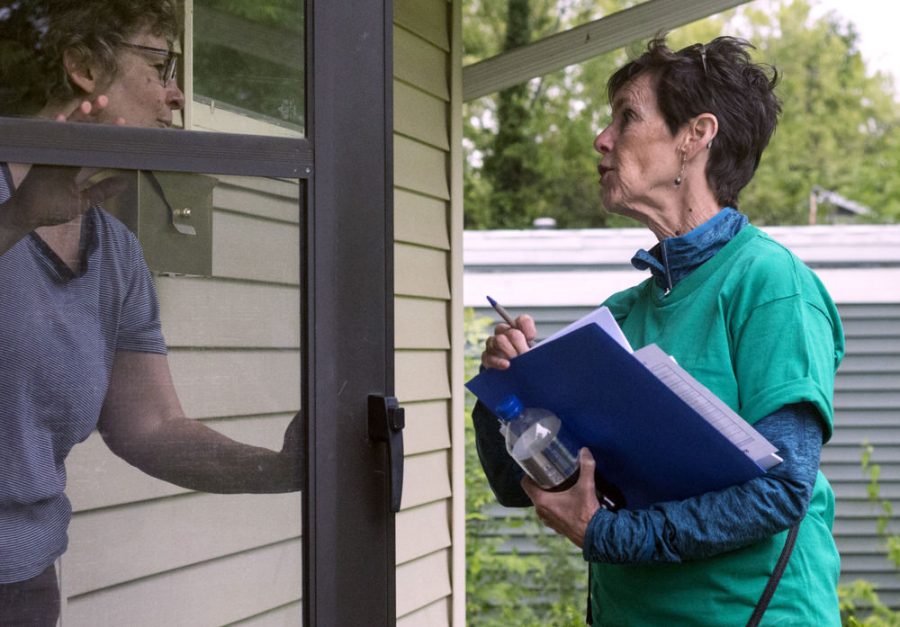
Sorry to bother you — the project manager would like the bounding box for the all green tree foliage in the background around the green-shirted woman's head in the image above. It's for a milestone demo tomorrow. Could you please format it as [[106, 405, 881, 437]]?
[[463, 0, 900, 229]]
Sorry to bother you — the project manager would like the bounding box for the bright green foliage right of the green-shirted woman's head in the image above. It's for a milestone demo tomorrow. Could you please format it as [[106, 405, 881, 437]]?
[[741, 1, 900, 224]]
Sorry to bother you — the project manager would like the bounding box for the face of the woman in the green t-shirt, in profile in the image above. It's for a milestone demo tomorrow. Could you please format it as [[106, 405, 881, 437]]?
[[594, 74, 681, 224]]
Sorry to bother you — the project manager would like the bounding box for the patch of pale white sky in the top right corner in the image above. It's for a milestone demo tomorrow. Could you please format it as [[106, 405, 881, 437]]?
[[817, 0, 900, 95]]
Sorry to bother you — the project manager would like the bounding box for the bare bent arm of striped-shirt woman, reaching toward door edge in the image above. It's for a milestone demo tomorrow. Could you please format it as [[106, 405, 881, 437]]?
[[98, 351, 302, 493]]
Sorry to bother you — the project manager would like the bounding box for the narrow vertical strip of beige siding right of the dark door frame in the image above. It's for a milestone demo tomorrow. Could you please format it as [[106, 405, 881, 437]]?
[[394, 0, 464, 627]]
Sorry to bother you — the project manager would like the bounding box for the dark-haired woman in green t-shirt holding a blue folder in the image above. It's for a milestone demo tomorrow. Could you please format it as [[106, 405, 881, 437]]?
[[474, 37, 844, 625]]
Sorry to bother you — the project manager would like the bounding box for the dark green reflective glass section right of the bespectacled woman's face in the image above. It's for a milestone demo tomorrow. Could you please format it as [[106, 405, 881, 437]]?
[[191, 0, 305, 136]]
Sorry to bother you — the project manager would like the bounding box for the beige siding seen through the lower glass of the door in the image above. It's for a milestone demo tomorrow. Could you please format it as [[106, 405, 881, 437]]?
[[60, 177, 302, 627]]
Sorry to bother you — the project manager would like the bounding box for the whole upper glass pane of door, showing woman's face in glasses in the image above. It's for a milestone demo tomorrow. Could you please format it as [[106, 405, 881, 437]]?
[[0, 0, 305, 137]]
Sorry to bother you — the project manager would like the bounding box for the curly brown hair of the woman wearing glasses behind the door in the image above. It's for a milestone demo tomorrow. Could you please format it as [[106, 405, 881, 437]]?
[[0, 0, 178, 115]]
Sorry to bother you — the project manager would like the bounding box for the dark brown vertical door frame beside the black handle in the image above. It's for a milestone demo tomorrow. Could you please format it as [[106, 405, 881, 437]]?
[[303, 0, 396, 625]]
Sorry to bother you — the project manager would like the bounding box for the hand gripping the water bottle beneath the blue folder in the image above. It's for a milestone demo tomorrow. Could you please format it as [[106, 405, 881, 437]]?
[[522, 448, 600, 548]]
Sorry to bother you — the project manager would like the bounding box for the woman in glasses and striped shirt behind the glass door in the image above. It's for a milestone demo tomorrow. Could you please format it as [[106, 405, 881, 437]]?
[[0, 0, 301, 626]]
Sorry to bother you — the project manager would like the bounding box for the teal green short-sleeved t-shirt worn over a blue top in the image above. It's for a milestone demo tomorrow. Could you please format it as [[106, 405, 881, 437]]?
[[591, 225, 844, 626]]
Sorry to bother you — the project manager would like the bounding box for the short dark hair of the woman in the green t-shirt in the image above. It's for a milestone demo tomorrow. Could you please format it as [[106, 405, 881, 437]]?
[[607, 35, 781, 207]]
